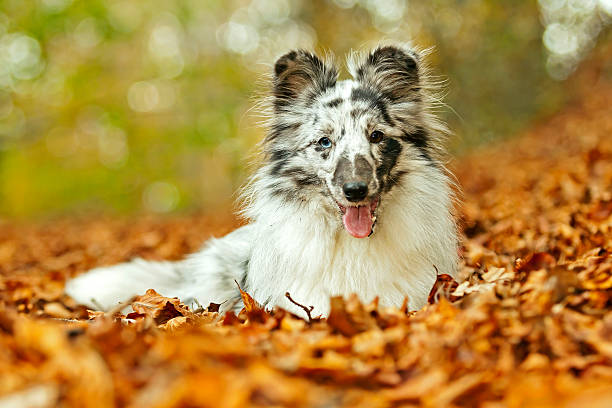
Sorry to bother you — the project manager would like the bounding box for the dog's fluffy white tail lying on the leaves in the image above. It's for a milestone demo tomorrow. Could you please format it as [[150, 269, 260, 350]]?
[[65, 259, 188, 310]]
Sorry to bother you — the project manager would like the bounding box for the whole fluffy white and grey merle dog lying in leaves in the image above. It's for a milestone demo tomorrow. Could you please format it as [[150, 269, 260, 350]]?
[[66, 45, 458, 315]]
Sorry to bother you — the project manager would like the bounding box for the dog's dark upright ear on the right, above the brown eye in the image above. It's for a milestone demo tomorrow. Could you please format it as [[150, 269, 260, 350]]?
[[351, 46, 420, 102]]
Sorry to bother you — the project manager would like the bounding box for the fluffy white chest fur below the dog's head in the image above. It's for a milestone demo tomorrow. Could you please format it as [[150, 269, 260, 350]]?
[[246, 170, 456, 315]]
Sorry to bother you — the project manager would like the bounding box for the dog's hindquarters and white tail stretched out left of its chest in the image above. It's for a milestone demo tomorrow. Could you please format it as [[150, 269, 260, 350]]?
[[65, 225, 254, 310]]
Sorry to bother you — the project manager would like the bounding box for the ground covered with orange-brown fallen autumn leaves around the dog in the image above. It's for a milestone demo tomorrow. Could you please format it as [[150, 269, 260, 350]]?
[[0, 85, 612, 408]]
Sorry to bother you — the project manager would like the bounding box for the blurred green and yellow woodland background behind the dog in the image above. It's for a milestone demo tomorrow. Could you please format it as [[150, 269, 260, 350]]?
[[0, 0, 612, 218]]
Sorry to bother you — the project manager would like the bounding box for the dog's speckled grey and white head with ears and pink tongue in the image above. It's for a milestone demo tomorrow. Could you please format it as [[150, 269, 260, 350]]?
[[265, 47, 435, 238]]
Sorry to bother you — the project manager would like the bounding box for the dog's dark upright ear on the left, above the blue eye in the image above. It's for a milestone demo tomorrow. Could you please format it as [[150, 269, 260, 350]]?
[[273, 50, 338, 110]]
